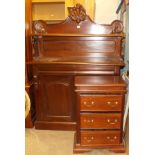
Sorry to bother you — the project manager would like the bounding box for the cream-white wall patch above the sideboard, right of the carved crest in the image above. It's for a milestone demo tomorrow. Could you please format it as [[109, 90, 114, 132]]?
[[95, 0, 119, 24]]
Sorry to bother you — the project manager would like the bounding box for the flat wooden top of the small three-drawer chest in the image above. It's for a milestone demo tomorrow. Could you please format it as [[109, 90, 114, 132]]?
[[75, 76, 126, 86]]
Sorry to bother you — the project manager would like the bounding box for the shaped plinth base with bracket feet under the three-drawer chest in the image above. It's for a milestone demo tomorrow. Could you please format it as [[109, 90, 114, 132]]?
[[73, 133, 126, 153]]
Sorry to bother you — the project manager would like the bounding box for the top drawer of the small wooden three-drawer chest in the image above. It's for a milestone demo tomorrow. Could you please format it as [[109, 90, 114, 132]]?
[[80, 95, 123, 111]]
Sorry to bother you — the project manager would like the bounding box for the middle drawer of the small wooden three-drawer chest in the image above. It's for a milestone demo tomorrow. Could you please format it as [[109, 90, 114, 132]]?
[[80, 113, 121, 129]]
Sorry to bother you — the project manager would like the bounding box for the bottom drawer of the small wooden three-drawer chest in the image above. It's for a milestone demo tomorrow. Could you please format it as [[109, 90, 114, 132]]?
[[81, 131, 120, 145]]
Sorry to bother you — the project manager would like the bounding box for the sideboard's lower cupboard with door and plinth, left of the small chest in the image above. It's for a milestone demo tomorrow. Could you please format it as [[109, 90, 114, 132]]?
[[35, 72, 75, 130]]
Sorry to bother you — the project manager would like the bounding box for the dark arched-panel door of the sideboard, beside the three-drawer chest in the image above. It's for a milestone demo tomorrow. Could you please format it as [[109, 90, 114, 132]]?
[[38, 75, 74, 122]]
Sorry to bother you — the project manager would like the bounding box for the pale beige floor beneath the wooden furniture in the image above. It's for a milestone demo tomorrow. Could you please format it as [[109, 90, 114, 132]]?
[[25, 129, 127, 155]]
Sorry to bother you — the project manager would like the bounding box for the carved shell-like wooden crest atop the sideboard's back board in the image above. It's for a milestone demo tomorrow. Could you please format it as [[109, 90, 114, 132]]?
[[68, 4, 86, 24]]
